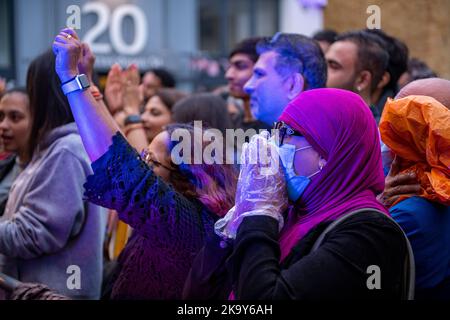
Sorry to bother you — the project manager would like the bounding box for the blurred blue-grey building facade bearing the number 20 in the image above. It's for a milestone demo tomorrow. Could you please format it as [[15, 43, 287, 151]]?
[[0, 0, 279, 87]]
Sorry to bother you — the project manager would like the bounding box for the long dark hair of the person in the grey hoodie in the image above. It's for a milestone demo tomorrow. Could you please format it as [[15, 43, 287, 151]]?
[[27, 50, 74, 157]]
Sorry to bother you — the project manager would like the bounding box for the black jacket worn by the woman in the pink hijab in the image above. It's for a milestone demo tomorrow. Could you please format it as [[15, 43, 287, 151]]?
[[184, 211, 407, 300]]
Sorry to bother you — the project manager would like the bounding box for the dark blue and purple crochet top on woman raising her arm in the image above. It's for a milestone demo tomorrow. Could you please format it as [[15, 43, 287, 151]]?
[[84, 133, 216, 299]]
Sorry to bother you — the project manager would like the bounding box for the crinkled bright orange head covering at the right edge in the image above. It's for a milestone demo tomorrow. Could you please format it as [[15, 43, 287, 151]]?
[[380, 96, 450, 205]]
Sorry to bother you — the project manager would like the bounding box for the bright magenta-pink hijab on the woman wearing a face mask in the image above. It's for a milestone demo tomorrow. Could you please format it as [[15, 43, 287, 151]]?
[[280, 89, 388, 260]]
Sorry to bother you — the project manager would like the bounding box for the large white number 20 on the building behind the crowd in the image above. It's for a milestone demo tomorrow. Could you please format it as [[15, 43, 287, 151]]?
[[66, 2, 147, 55]]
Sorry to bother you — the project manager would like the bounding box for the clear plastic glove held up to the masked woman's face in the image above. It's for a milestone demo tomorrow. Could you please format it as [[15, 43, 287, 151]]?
[[215, 131, 288, 239]]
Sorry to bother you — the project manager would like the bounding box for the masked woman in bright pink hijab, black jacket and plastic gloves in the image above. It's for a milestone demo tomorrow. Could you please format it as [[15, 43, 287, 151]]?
[[184, 89, 407, 300]]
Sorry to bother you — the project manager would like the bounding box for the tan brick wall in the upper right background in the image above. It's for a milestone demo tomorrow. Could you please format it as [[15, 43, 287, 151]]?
[[324, 0, 450, 79]]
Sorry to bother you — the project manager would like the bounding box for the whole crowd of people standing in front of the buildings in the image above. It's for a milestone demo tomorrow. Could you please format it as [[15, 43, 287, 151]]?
[[0, 24, 450, 300]]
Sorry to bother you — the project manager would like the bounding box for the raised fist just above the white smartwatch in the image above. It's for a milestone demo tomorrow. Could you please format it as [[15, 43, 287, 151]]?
[[53, 28, 83, 83]]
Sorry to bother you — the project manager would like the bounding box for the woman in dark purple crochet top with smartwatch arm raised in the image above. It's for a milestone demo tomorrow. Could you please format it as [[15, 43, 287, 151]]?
[[53, 29, 236, 299]]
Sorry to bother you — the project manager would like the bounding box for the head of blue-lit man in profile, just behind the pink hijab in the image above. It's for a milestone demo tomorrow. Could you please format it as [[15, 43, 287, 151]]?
[[244, 33, 327, 126]]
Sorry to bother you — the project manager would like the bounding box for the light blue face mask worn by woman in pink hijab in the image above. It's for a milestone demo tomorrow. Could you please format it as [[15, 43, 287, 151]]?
[[277, 143, 321, 202]]
